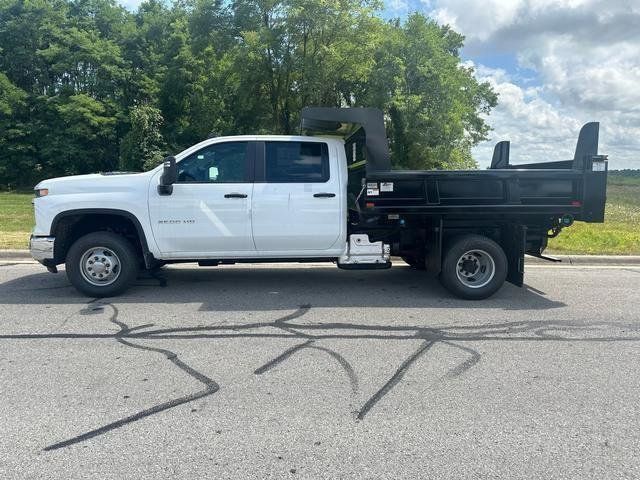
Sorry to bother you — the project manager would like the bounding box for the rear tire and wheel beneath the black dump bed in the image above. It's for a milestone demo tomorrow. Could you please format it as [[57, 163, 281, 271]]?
[[440, 235, 508, 300]]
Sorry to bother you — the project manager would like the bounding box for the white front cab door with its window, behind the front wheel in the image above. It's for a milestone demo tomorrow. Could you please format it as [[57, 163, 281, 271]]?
[[149, 141, 255, 258]]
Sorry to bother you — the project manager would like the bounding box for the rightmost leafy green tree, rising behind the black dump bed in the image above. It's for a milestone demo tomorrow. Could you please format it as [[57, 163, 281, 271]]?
[[360, 14, 497, 169]]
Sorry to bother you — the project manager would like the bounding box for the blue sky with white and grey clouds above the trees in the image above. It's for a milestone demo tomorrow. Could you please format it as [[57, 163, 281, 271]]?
[[120, 0, 640, 169]]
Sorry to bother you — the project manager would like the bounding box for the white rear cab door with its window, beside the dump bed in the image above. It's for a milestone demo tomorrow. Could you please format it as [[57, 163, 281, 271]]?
[[252, 141, 346, 253]]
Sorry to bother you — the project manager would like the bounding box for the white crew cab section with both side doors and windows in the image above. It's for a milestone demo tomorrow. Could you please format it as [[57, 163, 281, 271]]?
[[148, 136, 347, 260]]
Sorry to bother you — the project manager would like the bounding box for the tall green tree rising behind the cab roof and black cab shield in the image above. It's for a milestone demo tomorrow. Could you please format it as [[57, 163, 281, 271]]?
[[234, 0, 383, 133]]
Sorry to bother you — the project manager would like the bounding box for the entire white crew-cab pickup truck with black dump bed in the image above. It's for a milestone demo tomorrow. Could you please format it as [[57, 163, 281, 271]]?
[[30, 108, 606, 299]]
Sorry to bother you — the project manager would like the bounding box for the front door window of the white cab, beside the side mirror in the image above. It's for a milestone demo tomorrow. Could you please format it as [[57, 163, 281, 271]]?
[[178, 142, 249, 183]]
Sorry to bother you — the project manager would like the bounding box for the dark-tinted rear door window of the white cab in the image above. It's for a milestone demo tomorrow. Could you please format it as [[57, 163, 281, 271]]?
[[265, 142, 329, 183]]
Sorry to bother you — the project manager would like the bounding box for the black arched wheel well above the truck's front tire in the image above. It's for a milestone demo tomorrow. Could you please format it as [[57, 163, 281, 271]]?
[[51, 213, 147, 263]]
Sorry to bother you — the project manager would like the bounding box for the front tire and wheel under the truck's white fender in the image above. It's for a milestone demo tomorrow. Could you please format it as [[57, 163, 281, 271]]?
[[65, 232, 140, 298]]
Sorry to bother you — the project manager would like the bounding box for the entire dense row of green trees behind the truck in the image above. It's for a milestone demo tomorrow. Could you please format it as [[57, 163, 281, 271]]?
[[0, 0, 497, 185]]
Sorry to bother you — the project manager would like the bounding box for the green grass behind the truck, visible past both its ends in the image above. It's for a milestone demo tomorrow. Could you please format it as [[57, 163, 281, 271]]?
[[0, 174, 640, 255]]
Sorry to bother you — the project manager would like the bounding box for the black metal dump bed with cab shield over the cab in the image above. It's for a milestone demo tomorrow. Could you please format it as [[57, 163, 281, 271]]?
[[302, 107, 607, 222]]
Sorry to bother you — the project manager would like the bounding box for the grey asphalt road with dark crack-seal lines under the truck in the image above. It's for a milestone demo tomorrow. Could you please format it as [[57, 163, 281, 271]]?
[[0, 261, 640, 479]]
